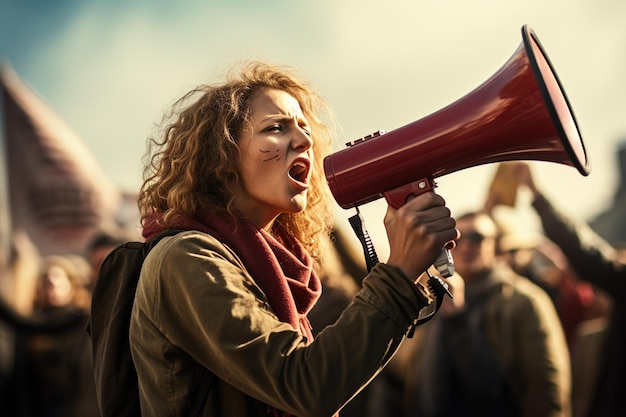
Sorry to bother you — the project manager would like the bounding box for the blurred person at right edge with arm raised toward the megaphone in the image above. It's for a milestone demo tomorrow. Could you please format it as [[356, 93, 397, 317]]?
[[509, 162, 626, 417]]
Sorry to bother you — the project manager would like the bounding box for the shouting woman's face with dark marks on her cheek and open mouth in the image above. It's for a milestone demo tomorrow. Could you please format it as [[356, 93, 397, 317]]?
[[235, 88, 313, 228]]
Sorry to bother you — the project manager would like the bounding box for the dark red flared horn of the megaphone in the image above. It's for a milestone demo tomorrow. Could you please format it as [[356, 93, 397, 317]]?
[[324, 25, 590, 209]]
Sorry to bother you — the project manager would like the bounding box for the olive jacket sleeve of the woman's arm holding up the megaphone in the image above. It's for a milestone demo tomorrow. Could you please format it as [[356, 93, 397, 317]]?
[[138, 232, 430, 416]]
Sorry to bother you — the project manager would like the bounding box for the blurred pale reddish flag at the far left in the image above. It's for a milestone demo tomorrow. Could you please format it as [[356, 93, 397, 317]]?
[[0, 63, 121, 255]]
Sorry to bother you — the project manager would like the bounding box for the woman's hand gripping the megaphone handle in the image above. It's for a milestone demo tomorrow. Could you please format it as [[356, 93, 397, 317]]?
[[384, 192, 459, 279]]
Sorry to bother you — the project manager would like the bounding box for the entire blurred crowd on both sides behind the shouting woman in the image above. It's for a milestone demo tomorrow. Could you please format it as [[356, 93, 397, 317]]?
[[0, 158, 626, 417]]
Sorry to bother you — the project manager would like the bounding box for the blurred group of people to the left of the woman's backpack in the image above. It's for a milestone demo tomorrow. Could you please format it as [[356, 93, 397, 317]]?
[[0, 228, 131, 417]]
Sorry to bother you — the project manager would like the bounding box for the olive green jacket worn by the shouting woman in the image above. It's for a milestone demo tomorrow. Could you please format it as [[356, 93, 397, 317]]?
[[130, 231, 430, 417]]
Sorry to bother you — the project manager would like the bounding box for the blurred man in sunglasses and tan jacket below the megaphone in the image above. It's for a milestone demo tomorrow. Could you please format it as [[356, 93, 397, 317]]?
[[396, 212, 571, 417]]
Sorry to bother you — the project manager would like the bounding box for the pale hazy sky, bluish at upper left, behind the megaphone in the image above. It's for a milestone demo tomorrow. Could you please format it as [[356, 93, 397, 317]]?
[[0, 0, 626, 251]]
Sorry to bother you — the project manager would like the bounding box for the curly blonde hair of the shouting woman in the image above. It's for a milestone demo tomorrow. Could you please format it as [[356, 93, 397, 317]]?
[[138, 62, 332, 258]]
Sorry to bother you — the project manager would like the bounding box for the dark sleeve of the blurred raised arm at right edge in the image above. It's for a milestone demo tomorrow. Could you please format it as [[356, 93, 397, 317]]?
[[533, 194, 626, 294]]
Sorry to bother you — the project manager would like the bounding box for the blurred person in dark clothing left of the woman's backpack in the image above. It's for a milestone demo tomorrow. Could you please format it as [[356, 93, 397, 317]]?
[[9, 255, 99, 417]]
